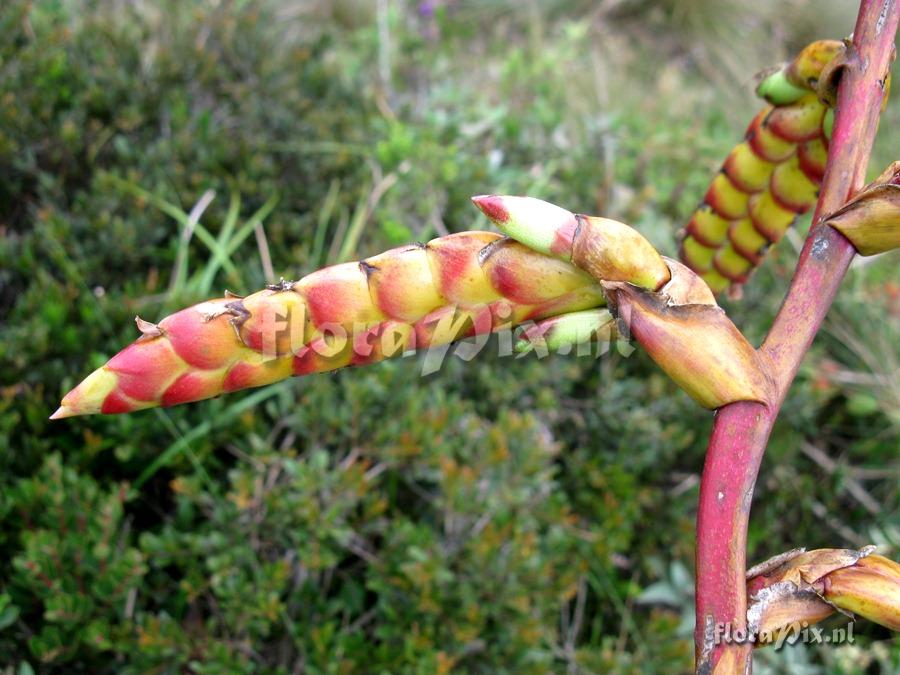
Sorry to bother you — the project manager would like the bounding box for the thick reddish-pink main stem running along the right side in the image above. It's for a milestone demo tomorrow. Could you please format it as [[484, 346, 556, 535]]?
[[694, 0, 900, 673]]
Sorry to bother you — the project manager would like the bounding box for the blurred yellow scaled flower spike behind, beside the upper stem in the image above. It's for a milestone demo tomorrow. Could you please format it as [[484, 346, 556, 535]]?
[[680, 40, 844, 293]]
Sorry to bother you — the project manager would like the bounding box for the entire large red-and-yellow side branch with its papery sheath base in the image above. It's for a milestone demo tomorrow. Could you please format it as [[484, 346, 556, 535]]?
[[53, 196, 769, 418]]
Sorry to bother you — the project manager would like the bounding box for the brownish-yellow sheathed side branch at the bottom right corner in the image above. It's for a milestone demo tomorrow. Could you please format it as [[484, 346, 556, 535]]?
[[747, 546, 900, 646]]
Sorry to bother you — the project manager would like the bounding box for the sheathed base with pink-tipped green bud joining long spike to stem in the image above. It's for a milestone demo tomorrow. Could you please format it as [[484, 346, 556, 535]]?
[[473, 195, 771, 408]]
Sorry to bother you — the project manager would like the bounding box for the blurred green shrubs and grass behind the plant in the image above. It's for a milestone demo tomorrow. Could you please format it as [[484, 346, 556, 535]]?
[[0, 0, 900, 675]]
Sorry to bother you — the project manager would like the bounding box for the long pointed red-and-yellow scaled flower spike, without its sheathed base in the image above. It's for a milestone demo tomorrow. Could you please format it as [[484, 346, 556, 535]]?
[[53, 232, 604, 418]]
